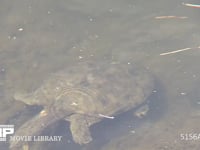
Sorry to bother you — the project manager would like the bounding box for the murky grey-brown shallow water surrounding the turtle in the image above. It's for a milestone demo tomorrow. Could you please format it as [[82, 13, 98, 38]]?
[[0, 0, 200, 150]]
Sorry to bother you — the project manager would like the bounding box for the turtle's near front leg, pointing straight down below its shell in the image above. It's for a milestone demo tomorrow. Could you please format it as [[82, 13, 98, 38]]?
[[66, 114, 92, 145]]
